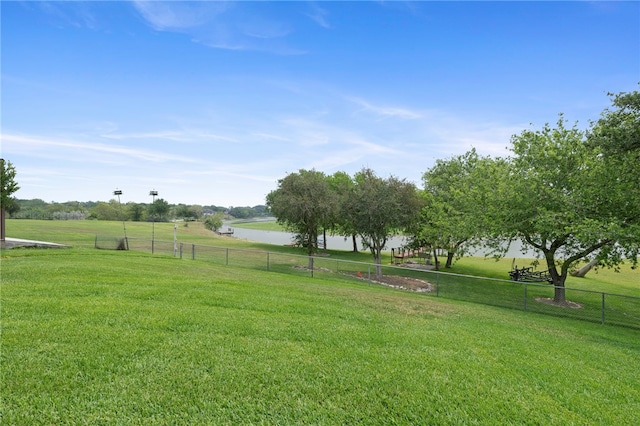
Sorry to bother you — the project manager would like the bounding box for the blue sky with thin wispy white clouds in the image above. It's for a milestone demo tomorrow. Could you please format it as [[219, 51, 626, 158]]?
[[0, 1, 640, 206]]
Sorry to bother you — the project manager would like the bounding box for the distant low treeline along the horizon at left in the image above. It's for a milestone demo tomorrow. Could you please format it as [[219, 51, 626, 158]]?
[[7, 198, 267, 221]]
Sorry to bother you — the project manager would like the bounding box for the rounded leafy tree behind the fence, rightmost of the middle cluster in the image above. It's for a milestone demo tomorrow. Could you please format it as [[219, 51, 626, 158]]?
[[345, 168, 422, 277]]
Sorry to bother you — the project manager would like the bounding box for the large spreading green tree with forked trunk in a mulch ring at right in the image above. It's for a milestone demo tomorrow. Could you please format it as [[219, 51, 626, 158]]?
[[486, 112, 640, 304]]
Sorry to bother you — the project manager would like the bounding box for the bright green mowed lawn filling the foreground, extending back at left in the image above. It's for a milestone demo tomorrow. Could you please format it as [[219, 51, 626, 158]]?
[[0, 221, 640, 425]]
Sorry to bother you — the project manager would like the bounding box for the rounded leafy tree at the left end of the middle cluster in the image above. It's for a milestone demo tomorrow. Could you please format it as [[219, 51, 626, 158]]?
[[267, 170, 337, 262]]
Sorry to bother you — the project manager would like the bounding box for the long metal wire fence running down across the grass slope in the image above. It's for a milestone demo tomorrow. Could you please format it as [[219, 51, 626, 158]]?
[[128, 238, 640, 329]]
